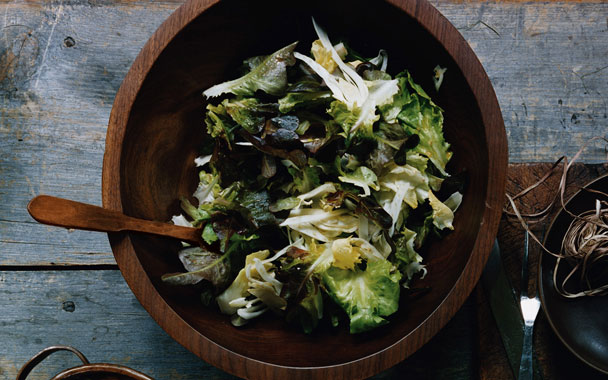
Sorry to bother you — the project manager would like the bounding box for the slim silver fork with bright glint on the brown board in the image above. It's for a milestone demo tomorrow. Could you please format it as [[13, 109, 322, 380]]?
[[518, 231, 540, 380]]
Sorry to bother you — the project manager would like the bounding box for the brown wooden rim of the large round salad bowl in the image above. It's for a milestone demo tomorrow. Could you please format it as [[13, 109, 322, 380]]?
[[102, 0, 508, 379]]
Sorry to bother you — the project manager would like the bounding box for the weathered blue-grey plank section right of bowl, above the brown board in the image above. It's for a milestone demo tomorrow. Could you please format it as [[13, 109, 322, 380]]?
[[432, 0, 608, 163]]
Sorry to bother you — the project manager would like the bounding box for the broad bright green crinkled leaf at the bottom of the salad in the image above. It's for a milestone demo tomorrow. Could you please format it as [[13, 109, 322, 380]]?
[[323, 260, 401, 334]]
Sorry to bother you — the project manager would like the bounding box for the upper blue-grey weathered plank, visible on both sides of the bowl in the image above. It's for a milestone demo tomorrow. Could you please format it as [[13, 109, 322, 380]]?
[[0, 0, 608, 265]]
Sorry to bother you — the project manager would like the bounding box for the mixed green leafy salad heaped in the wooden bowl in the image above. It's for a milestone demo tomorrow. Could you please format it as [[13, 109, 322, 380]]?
[[162, 20, 462, 333]]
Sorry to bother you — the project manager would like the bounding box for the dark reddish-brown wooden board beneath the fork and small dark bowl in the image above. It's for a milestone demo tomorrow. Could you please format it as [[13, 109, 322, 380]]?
[[486, 163, 608, 380]]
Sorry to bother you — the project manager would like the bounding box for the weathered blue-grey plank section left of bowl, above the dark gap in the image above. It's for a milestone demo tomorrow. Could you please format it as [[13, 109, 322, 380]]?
[[0, 1, 179, 265]]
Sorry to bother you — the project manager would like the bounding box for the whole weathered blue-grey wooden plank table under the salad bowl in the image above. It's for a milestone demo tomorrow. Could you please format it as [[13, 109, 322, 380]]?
[[0, 0, 608, 379]]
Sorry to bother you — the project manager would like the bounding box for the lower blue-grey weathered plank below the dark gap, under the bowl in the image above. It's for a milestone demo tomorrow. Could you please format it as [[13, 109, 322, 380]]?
[[0, 270, 476, 380]]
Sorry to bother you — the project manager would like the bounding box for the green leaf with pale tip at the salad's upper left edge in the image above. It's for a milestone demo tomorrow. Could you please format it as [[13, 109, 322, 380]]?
[[203, 42, 298, 98]]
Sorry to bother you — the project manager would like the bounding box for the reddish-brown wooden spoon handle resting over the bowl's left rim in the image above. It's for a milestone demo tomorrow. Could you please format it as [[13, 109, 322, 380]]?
[[27, 195, 202, 244]]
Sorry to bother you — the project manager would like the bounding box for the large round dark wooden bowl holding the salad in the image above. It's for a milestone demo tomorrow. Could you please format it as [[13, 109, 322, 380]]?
[[103, 0, 507, 379]]
